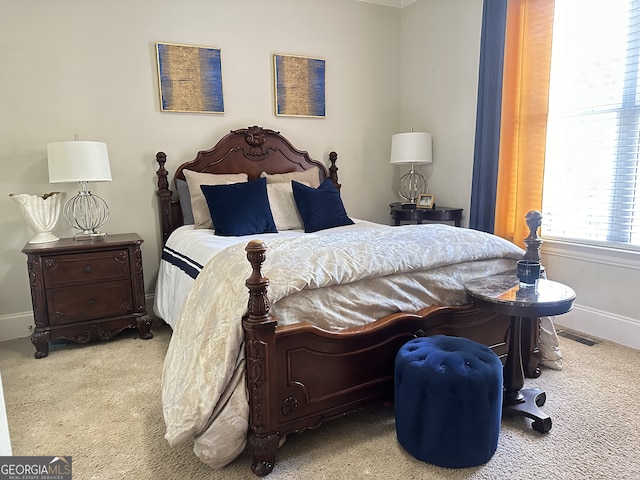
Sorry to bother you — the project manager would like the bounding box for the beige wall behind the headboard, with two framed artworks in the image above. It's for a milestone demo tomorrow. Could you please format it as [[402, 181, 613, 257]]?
[[0, 0, 400, 339]]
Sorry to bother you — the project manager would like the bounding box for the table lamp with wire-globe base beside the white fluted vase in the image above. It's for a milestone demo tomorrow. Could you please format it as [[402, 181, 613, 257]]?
[[47, 140, 111, 240]]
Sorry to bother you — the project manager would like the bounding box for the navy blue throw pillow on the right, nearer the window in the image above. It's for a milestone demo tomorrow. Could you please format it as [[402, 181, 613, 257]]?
[[292, 178, 353, 233]]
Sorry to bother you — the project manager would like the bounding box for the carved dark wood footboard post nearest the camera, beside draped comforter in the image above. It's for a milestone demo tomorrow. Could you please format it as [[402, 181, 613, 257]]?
[[242, 240, 280, 476]]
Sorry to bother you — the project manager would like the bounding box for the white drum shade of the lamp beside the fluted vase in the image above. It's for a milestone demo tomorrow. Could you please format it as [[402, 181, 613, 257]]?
[[47, 141, 111, 183]]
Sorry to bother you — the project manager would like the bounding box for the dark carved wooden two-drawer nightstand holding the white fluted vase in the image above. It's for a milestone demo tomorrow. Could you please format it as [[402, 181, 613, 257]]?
[[22, 233, 153, 358]]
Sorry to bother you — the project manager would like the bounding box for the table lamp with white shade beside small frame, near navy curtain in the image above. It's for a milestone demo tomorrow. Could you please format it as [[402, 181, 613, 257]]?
[[391, 132, 433, 205]]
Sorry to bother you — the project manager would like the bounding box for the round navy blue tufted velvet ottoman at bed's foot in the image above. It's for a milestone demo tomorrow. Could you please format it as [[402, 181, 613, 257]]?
[[394, 335, 502, 468]]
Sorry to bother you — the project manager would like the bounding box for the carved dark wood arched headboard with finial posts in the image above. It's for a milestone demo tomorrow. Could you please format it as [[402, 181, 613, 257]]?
[[156, 125, 340, 245]]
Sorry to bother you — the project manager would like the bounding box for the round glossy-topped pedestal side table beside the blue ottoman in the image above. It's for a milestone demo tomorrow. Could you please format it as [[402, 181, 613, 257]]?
[[465, 275, 576, 432]]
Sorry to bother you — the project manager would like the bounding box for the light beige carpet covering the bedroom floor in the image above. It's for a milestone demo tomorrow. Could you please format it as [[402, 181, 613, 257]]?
[[0, 327, 640, 480]]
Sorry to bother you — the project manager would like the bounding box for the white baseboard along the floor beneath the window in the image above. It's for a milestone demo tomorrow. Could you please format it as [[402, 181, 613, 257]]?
[[553, 305, 640, 350]]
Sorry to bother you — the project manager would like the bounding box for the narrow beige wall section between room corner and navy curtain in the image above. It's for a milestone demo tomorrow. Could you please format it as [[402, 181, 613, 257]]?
[[401, 0, 482, 219]]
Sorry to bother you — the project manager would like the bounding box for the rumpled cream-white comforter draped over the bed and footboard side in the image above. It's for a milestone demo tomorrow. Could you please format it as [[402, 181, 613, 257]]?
[[162, 224, 523, 467]]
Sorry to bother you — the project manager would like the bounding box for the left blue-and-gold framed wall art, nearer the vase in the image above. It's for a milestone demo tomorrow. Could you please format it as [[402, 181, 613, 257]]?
[[156, 43, 224, 113]]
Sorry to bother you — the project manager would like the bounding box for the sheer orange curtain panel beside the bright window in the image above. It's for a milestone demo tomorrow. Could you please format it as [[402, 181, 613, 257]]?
[[494, 0, 554, 247]]
